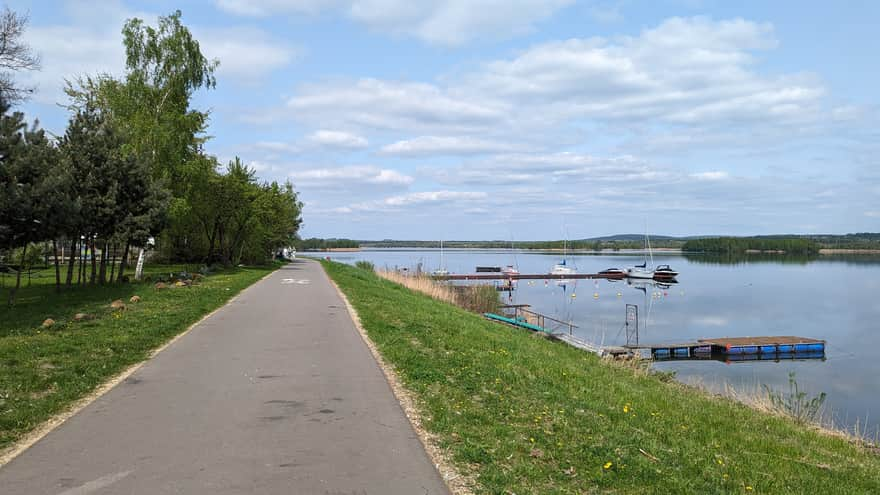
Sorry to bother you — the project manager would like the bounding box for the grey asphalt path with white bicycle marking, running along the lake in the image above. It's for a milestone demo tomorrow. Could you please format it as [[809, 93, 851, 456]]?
[[0, 260, 448, 495]]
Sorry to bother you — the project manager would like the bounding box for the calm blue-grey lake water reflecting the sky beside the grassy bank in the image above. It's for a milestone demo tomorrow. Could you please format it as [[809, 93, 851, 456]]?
[[320, 249, 880, 436]]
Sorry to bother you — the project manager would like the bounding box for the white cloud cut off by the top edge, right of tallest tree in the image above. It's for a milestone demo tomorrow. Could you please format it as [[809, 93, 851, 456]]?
[[216, 0, 574, 45]]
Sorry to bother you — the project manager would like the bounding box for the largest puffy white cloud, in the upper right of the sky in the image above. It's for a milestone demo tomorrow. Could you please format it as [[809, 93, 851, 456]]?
[[467, 17, 824, 124]]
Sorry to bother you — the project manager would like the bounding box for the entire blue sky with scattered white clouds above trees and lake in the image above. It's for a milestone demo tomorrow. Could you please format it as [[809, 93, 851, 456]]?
[[7, 0, 880, 240]]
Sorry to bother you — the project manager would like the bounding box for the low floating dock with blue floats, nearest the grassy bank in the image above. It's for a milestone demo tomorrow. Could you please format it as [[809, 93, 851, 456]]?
[[630, 335, 825, 359]]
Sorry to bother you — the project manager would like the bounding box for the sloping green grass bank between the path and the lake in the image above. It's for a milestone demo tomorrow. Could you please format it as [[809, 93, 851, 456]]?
[[323, 262, 880, 494]]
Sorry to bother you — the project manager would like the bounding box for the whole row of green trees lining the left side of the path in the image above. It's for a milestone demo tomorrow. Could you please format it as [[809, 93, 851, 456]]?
[[0, 9, 302, 303]]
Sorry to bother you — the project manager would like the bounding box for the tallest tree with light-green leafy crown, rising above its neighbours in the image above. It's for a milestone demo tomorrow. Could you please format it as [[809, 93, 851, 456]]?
[[67, 10, 219, 198]]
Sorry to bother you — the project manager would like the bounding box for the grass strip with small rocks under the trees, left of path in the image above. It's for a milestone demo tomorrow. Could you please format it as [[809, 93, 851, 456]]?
[[0, 265, 277, 453]]
